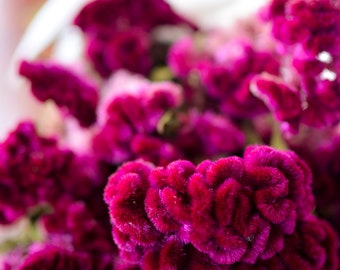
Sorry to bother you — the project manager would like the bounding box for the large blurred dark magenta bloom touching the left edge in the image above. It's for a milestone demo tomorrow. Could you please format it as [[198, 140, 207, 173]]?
[[0, 122, 105, 224]]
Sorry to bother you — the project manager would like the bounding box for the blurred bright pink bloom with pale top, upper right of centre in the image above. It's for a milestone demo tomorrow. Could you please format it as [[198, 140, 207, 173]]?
[[168, 35, 279, 118]]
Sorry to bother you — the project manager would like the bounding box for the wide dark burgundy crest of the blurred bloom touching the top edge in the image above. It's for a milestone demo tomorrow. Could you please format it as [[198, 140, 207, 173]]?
[[74, 0, 194, 39]]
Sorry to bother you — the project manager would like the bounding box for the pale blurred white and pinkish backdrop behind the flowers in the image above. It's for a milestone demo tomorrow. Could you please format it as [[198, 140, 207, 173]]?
[[0, 0, 266, 140]]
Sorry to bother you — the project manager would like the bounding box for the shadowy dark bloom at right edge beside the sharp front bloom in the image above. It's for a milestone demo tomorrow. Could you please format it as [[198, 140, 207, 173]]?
[[290, 131, 340, 232]]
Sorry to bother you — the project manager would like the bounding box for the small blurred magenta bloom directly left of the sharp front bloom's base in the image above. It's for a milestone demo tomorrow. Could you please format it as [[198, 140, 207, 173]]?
[[41, 199, 116, 269]]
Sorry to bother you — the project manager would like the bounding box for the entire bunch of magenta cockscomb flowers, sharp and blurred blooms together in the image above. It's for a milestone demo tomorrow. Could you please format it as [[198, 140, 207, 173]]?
[[0, 0, 340, 270]]
